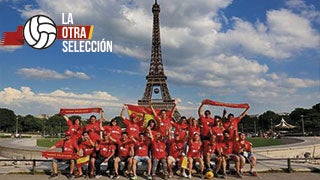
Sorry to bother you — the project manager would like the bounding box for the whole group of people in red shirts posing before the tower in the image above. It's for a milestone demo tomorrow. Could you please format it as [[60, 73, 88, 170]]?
[[49, 101, 257, 179]]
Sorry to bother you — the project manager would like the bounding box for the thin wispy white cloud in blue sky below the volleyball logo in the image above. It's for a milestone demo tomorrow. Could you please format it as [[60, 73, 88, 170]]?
[[17, 68, 90, 80]]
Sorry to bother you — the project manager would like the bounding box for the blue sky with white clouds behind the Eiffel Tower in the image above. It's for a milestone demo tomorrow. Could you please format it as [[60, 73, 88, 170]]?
[[0, 0, 320, 118]]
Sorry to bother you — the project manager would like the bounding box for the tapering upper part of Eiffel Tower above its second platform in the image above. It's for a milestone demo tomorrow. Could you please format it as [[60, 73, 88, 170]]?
[[148, 0, 166, 78]]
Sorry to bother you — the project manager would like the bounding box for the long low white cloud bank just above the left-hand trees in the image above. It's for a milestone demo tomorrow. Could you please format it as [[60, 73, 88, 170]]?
[[0, 87, 121, 114]]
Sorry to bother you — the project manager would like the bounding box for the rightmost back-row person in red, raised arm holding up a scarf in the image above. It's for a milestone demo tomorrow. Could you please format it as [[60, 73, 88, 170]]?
[[222, 105, 250, 139]]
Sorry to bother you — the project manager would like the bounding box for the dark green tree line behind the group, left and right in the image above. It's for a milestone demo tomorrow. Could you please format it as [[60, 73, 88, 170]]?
[[0, 103, 320, 136]]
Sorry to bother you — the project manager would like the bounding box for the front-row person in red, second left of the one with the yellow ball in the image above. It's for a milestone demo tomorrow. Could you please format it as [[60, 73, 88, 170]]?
[[168, 132, 188, 178]]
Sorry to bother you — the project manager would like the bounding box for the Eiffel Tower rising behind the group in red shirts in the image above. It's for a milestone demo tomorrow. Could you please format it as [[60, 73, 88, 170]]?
[[138, 0, 175, 110]]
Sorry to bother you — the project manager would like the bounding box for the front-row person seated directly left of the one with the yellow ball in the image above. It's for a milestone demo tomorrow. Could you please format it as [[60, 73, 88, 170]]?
[[187, 132, 204, 179]]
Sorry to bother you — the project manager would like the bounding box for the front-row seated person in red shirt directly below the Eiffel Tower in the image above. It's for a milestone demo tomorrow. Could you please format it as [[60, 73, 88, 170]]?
[[149, 129, 168, 179]]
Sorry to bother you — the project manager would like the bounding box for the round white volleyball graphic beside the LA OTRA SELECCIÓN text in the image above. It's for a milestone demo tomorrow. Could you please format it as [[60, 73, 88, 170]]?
[[23, 15, 57, 49]]
